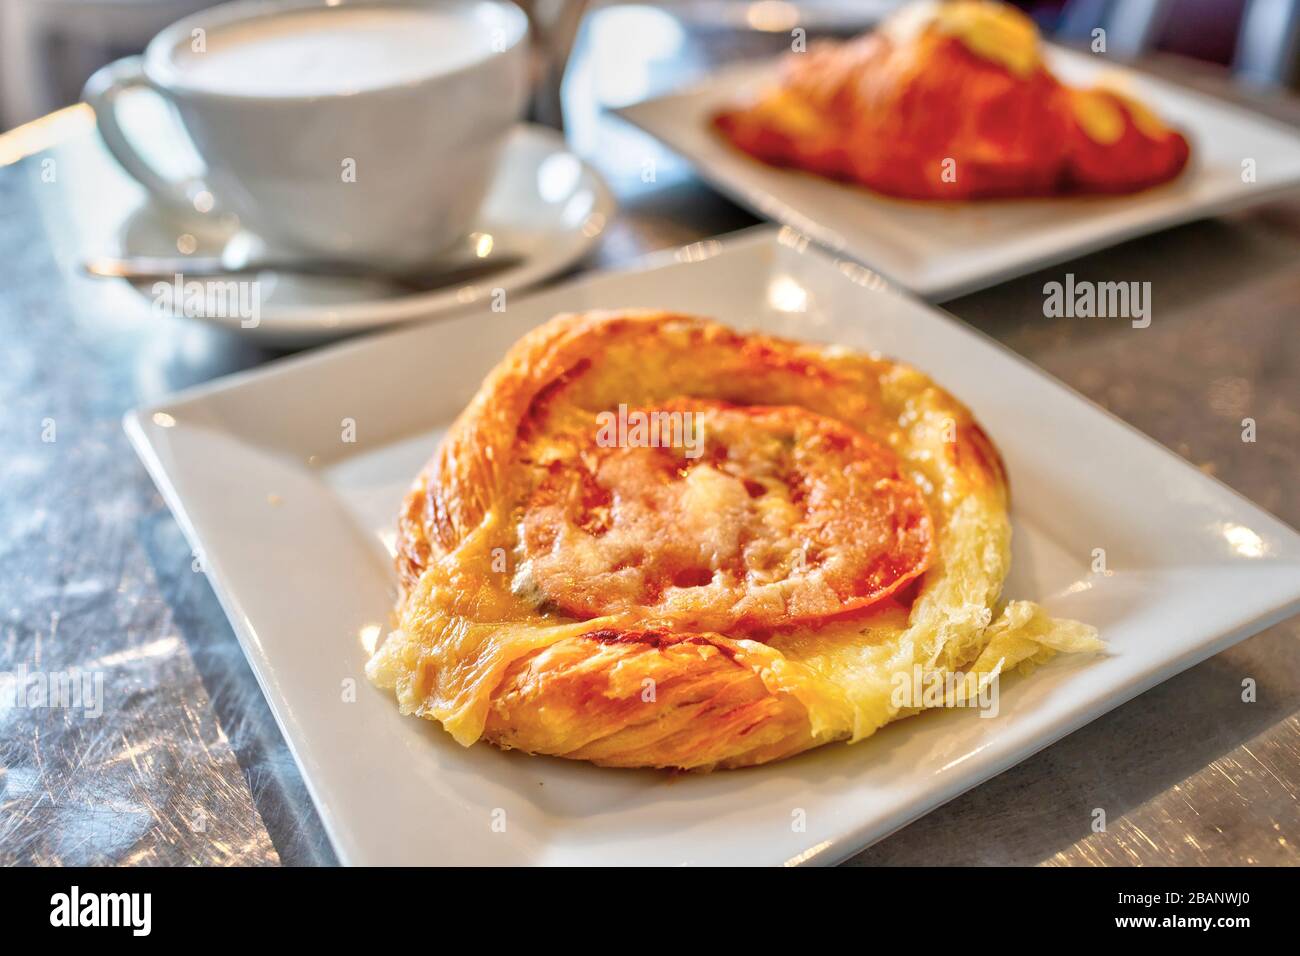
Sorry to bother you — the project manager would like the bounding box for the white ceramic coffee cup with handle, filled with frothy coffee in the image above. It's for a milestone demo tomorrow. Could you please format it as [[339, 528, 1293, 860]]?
[[83, 0, 528, 261]]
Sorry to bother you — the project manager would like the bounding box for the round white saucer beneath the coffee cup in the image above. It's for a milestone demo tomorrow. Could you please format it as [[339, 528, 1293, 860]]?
[[118, 124, 618, 346]]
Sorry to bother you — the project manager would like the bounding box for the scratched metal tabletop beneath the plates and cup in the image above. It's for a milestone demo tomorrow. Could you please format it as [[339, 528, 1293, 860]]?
[[0, 8, 1300, 865]]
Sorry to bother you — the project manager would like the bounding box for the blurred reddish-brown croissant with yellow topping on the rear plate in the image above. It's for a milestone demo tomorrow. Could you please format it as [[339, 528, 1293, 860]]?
[[714, 0, 1188, 199]]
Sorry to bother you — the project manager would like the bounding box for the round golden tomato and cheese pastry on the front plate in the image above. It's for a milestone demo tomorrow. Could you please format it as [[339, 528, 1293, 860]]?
[[368, 311, 1102, 769]]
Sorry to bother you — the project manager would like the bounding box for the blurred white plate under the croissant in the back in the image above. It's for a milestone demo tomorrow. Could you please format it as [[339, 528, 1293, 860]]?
[[616, 48, 1300, 302]]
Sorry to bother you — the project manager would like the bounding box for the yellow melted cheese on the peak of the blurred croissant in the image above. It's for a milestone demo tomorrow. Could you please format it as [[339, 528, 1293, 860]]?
[[880, 0, 1043, 77]]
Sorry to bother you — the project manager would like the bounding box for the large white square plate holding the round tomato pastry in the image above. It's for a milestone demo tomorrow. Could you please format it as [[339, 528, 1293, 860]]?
[[126, 228, 1300, 864]]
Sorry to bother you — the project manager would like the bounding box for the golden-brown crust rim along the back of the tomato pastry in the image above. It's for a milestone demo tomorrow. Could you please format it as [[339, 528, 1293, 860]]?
[[398, 312, 1005, 587]]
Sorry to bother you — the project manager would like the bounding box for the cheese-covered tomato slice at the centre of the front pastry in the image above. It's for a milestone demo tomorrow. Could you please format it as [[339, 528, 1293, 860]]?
[[514, 401, 933, 630]]
